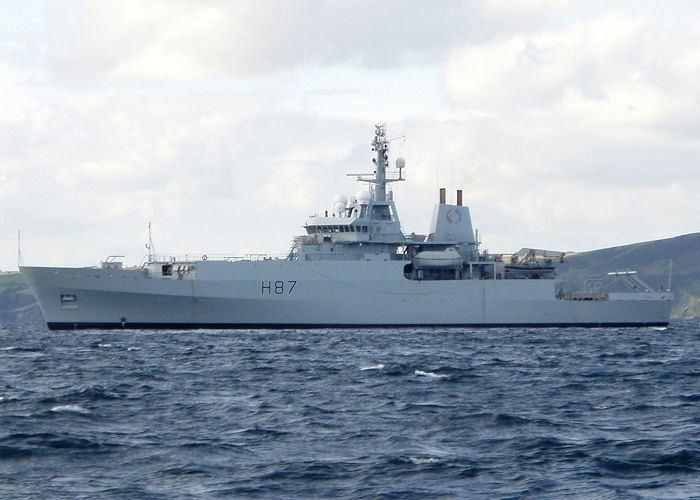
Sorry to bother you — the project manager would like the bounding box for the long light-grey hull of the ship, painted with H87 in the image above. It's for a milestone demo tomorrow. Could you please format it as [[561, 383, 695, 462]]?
[[21, 259, 671, 329]]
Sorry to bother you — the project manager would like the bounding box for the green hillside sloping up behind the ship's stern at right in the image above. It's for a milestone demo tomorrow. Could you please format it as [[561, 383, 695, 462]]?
[[557, 233, 700, 318]]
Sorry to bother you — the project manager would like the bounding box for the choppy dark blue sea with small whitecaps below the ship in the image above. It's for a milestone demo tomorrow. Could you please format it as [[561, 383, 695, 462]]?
[[0, 320, 700, 499]]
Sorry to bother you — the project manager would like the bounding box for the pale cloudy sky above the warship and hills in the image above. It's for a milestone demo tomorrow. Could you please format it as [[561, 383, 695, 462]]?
[[0, 0, 700, 271]]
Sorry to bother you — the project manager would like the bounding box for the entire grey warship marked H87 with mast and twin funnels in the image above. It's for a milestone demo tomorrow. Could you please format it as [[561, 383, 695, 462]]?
[[20, 124, 673, 329]]
